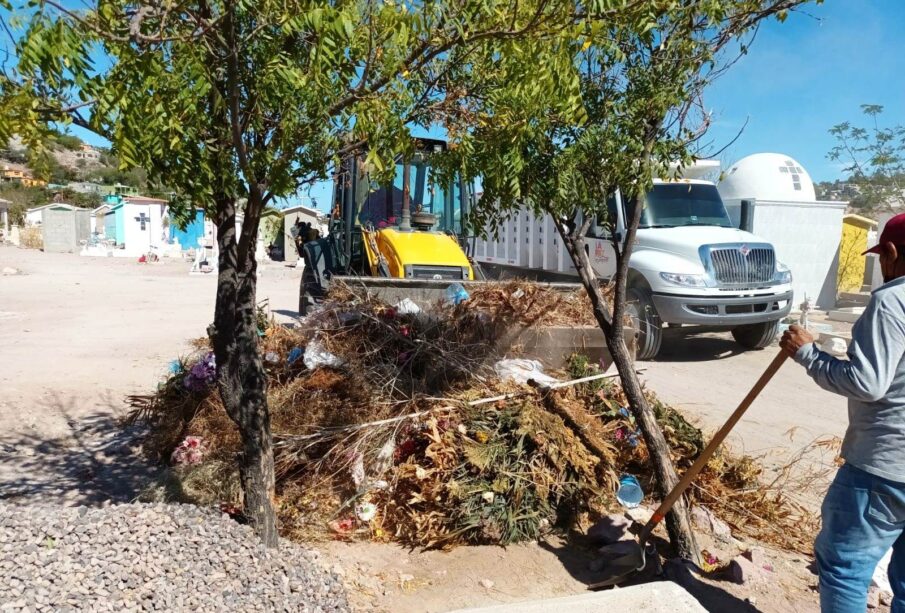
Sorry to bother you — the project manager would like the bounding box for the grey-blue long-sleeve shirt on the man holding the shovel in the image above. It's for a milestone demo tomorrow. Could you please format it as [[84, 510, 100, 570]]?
[[795, 277, 905, 483]]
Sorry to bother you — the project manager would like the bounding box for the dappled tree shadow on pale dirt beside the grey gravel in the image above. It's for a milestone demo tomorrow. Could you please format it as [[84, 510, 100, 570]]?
[[0, 397, 160, 506]]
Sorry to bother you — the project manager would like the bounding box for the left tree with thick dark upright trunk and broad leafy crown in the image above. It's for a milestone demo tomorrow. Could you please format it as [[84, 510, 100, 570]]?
[[0, 0, 588, 545]]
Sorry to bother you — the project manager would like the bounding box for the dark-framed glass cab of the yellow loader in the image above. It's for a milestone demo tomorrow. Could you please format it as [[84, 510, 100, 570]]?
[[330, 139, 474, 274]]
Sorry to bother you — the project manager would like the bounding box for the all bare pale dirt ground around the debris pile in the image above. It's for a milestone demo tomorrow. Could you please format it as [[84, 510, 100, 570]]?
[[0, 247, 846, 611]]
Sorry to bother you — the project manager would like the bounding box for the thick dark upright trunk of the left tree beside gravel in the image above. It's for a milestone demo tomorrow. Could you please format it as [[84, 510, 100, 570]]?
[[208, 196, 279, 547]]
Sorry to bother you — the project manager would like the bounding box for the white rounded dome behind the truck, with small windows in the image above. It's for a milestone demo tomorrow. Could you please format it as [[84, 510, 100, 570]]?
[[719, 153, 817, 202]]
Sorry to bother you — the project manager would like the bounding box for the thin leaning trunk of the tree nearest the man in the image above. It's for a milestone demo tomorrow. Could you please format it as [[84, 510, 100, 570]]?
[[557, 223, 700, 563]]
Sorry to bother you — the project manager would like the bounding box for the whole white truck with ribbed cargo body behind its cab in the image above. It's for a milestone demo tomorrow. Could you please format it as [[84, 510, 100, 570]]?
[[474, 161, 792, 359]]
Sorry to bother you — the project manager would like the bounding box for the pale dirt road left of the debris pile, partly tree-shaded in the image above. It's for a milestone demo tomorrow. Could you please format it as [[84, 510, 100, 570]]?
[[0, 247, 300, 504]]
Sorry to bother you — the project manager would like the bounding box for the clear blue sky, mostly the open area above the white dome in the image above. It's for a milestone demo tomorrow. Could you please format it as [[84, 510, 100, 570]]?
[[4, 0, 905, 210]]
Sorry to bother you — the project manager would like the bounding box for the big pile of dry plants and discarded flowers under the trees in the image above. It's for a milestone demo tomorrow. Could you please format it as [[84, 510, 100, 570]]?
[[131, 282, 816, 551]]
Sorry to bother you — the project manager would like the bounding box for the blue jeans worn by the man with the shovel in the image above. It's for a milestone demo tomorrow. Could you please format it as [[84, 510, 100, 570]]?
[[814, 464, 905, 613]]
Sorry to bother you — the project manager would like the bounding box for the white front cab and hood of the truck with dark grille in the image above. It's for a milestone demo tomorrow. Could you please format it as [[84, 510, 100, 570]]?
[[586, 179, 792, 359]]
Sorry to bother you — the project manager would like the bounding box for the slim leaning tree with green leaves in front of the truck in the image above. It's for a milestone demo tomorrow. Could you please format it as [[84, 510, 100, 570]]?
[[449, 0, 816, 559]]
